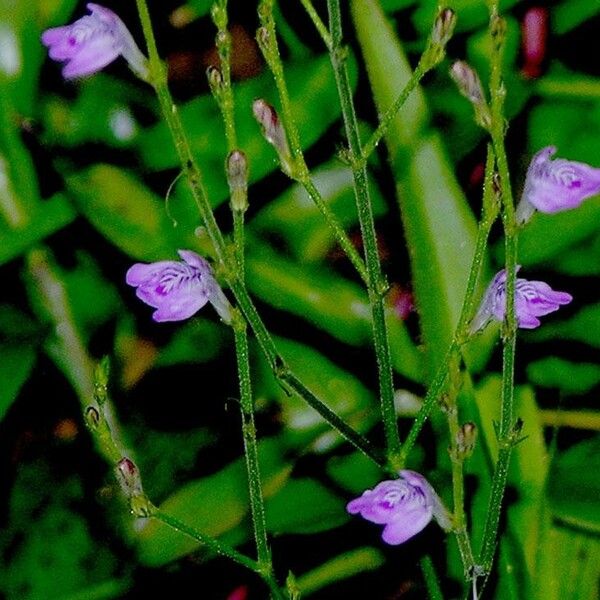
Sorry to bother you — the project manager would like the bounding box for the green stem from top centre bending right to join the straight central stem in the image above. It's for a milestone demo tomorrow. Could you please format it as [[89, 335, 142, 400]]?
[[259, 0, 368, 284]]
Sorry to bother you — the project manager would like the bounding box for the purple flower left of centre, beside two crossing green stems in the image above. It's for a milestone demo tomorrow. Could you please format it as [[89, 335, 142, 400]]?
[[125, 250, 231, 323]]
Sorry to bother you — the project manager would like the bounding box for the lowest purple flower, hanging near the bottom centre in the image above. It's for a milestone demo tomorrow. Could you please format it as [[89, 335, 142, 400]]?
[[346, 470, 451, 545]]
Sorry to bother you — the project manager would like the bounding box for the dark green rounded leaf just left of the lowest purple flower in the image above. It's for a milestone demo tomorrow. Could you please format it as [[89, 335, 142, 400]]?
[[265, 478, 348, 534]]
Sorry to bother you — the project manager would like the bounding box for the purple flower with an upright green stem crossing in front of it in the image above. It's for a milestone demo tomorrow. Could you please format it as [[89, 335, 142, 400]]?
[[471, 265, 573, 333]]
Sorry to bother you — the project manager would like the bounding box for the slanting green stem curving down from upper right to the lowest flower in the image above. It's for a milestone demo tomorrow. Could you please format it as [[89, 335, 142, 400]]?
[[400, 148, 498, 465]]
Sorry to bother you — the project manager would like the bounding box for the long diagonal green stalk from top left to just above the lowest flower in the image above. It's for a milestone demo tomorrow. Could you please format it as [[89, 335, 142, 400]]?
[[136, 0, 379, 463]]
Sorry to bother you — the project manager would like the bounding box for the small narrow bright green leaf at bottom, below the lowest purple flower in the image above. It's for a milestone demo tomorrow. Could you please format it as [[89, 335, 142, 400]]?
[[297, 547, 385, 597]]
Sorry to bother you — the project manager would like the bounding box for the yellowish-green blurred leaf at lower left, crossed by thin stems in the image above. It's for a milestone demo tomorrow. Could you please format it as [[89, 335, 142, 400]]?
[[138, 438, 291, 566]]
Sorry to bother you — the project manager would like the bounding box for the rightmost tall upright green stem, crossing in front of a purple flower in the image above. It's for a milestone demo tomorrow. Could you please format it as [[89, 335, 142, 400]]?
[[479, 0, 518, 573]]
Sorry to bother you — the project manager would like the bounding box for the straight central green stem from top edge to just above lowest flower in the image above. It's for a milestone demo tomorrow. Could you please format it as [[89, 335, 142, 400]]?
[[327, 0, 401, 467]]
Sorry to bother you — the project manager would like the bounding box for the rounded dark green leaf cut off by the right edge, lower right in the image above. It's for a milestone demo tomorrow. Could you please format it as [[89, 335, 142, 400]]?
[[548, 435, 600, 533]]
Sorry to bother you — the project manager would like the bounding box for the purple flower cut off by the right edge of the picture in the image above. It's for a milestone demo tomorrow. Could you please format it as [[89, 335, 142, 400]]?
[[516, 146, 600, 223]]
